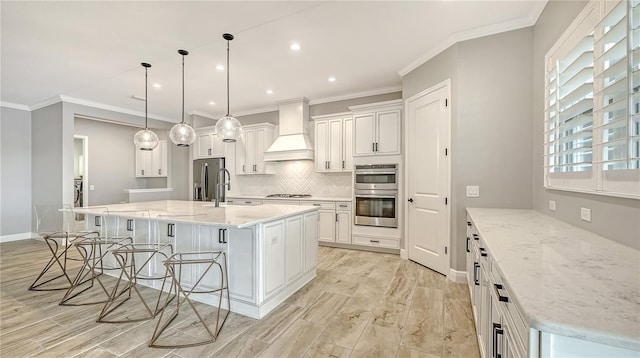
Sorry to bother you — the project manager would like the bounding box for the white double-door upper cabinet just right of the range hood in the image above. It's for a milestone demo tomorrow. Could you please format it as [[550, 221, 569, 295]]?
[[313, 114, 353, 172]]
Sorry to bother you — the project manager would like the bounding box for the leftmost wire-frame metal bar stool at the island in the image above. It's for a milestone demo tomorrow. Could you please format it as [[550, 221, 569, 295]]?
[[29, 205, 97, 291]]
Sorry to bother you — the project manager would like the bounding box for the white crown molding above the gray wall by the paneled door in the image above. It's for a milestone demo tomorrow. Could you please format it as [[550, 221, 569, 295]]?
[[398, 0, 547, 77]]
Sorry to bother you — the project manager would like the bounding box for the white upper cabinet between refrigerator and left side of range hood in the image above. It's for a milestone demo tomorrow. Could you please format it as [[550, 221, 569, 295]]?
[[236, 123, 276, 175]]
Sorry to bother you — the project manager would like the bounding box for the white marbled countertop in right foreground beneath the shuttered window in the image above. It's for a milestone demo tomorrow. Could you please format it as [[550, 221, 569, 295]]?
[[467, 208, 640, 350]]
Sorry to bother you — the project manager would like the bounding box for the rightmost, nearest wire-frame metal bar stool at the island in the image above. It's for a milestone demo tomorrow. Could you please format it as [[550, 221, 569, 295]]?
[[149, 251, 231, 348]]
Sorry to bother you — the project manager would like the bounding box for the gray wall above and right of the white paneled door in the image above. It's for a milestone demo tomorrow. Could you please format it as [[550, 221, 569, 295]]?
[[403, 28, 532, 270]]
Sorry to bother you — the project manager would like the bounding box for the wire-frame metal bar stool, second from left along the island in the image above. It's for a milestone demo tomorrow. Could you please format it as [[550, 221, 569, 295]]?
[[60, 208, 133, 306]]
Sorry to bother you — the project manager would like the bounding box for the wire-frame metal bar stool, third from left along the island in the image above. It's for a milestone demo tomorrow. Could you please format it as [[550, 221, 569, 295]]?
[[96, 243, 175, 323]]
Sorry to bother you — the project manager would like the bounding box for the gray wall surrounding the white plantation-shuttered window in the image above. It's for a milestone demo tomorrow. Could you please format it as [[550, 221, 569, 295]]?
[[533, 0, 640, 249]]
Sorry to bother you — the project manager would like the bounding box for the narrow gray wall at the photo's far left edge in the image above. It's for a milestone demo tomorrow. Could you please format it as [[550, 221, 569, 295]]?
[[0, 107, 31, 236]]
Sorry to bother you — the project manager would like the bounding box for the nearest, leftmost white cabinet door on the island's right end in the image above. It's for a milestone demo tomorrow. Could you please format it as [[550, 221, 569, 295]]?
[[262, 220, 284, 300]]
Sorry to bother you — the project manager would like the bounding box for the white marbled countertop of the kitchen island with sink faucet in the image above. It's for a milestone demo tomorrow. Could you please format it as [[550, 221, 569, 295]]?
[[74, 200, 318, 228]]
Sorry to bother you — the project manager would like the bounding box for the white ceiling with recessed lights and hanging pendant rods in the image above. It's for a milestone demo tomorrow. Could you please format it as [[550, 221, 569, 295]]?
[[0, 0, 546, 122]]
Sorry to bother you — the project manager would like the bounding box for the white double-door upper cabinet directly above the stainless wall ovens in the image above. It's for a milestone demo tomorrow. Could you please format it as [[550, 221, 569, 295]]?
[[349, 100, 402, 156]]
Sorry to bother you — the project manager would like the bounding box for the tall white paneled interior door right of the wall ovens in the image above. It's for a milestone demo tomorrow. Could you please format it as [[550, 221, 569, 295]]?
[[405, 82, 450, 274]]
